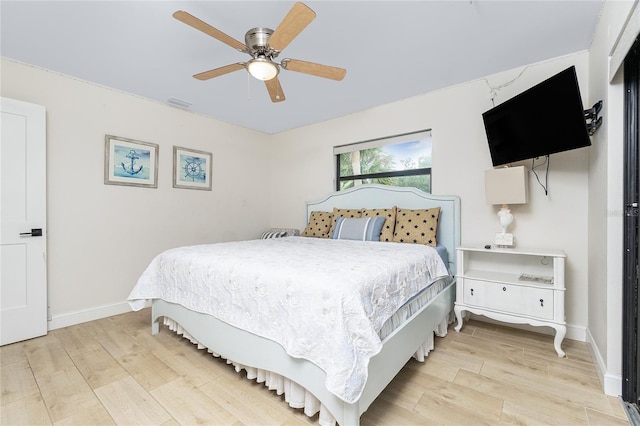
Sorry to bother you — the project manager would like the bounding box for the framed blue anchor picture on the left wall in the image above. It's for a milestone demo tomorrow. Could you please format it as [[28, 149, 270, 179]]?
[[104, 135, 158, 188]]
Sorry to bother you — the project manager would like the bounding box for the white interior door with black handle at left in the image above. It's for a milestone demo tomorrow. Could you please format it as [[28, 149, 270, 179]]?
[[0, 98, 47, 345]]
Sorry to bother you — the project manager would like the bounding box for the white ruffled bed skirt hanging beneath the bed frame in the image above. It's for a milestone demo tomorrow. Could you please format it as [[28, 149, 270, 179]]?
[[164, 312, 454, 426]]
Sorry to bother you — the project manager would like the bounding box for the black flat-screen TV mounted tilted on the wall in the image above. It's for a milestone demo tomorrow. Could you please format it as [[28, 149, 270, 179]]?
[[482, 66, 591, 166]]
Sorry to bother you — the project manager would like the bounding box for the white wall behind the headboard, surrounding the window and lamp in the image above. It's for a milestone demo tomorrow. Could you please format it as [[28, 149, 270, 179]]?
[[271, 52, 592, 340]]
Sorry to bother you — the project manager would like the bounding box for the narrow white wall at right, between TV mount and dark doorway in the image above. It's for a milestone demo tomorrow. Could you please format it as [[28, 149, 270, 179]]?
[[588, 1, 633, 395]]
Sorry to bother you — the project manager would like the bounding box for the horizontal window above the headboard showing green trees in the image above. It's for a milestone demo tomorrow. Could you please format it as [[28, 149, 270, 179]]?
[[333, 130, 431, 193]]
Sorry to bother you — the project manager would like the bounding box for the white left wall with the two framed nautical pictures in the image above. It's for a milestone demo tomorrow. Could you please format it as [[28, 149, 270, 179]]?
[[1, 60, 270, 328]]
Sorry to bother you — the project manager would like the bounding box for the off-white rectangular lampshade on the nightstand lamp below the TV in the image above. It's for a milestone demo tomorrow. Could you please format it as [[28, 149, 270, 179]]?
[[484, 166, 528, 204]]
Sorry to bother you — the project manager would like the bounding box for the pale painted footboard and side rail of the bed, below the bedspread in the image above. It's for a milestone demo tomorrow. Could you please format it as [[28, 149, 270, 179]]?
[[152, 281, 455, 426]]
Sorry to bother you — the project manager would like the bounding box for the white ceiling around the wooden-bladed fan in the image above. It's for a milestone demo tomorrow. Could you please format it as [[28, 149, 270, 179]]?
[[0, 0, 603, 133]]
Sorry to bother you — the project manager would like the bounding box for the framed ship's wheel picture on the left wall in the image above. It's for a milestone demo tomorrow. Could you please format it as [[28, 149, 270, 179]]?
[[173, 146, 212, 191]]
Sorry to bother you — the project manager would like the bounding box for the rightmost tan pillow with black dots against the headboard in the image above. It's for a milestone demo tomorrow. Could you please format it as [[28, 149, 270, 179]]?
[[393, 207, 440, 247]]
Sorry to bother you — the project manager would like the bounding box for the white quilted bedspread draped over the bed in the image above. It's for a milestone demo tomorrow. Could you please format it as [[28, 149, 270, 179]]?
[[128, 237, 448, 403]]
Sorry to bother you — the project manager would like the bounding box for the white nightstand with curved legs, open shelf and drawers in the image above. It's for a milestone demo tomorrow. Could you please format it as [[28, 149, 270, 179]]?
[[454, 247, 567, 357]]
